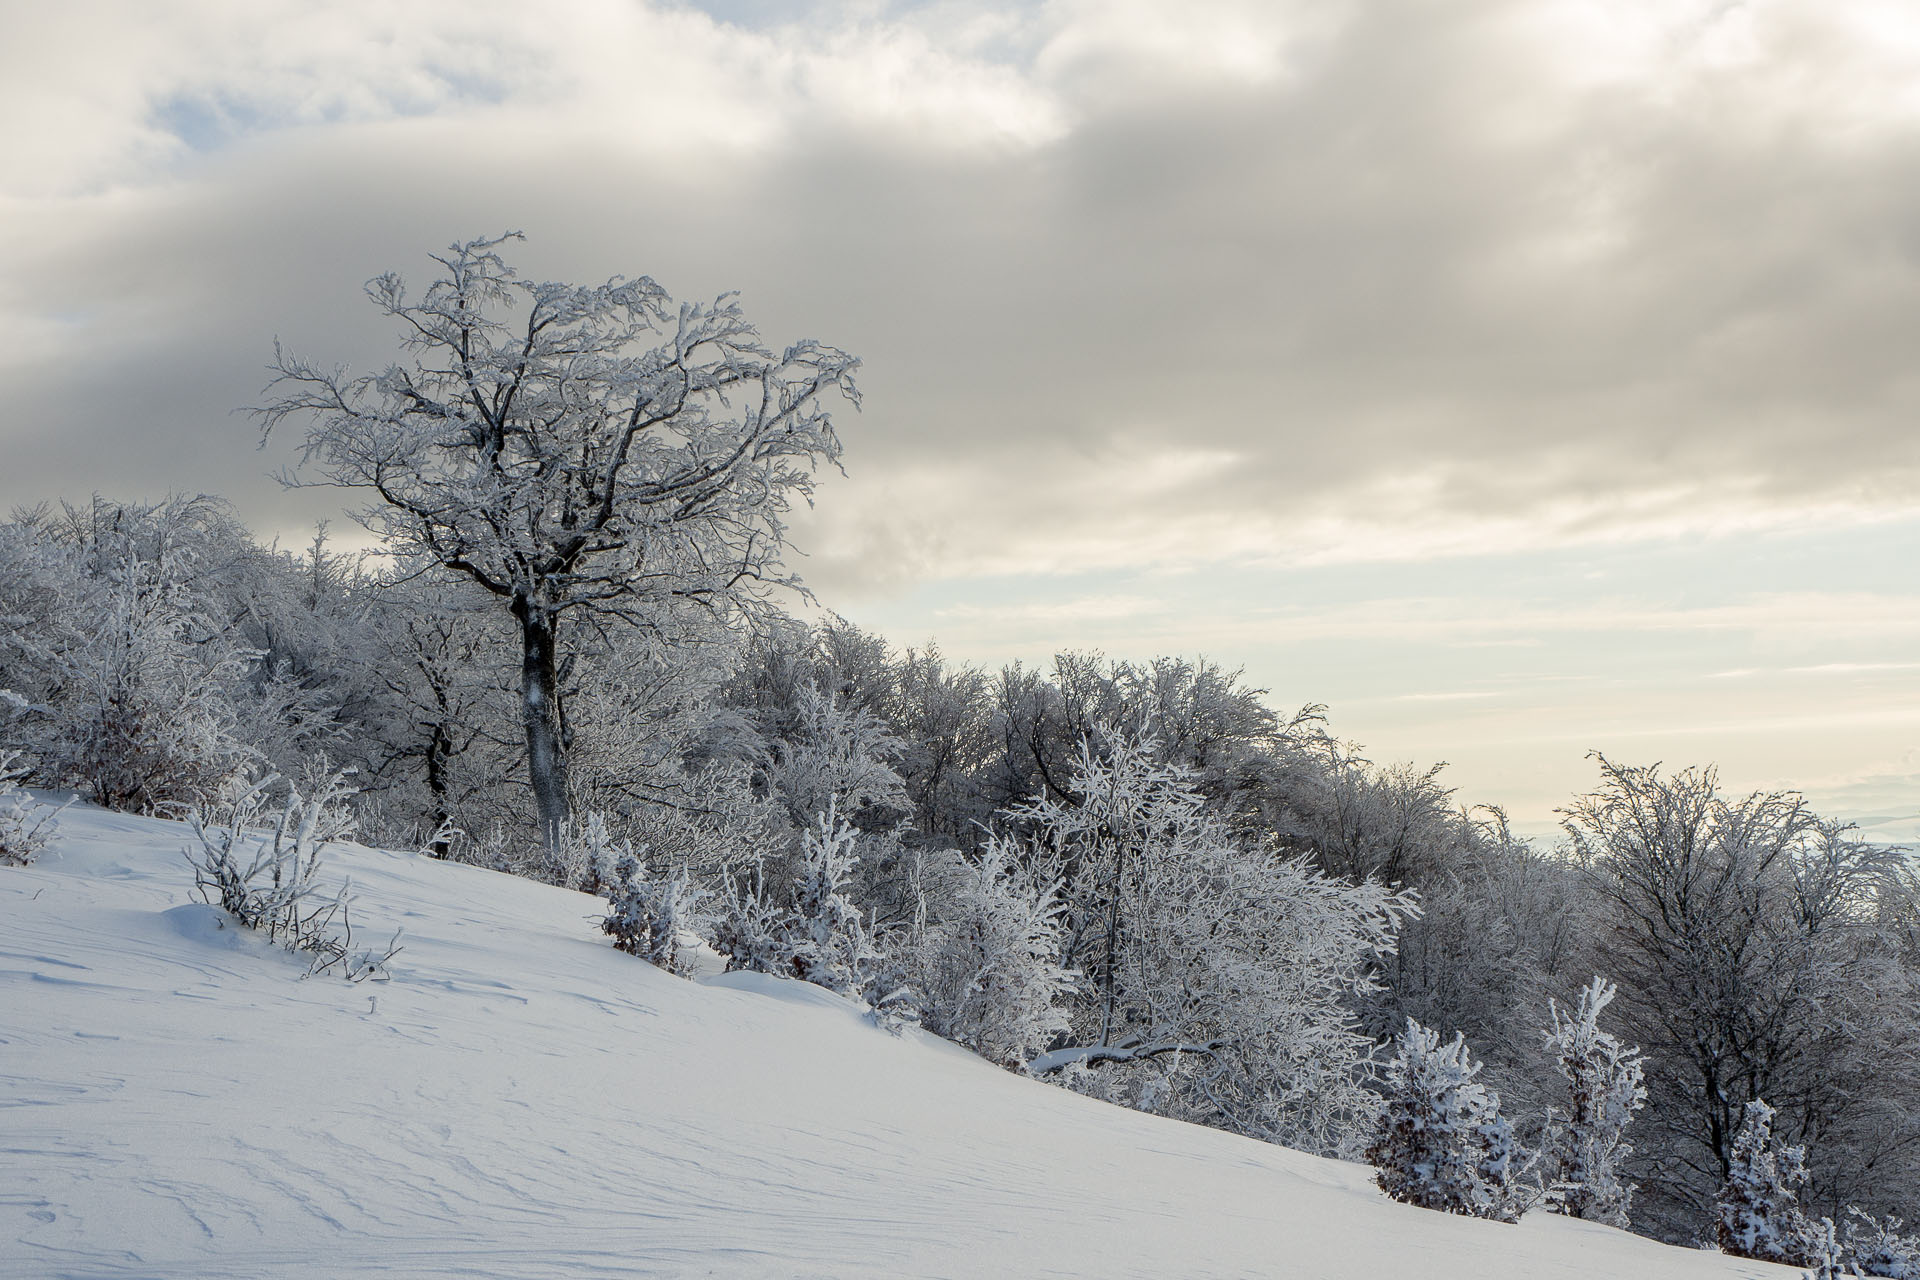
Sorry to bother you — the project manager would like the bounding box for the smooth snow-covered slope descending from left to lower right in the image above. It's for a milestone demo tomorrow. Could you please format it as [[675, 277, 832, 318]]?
[[0, 808, 1793, 1280]]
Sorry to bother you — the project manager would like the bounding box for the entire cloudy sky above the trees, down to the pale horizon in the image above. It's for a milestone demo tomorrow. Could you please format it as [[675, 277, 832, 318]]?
[[0, 0, 1920, 835]]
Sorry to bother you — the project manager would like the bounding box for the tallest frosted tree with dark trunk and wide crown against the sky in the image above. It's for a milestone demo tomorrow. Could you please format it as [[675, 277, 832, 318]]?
[[259, 234, 856, 841]]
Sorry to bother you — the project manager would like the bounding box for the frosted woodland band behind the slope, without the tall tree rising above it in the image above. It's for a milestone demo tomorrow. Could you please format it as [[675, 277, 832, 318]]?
[[0, 497, 1920, 1240]]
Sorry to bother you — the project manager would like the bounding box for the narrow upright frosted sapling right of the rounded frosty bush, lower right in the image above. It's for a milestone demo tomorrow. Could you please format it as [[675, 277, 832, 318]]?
[[1542, 977, 1647, 1226]]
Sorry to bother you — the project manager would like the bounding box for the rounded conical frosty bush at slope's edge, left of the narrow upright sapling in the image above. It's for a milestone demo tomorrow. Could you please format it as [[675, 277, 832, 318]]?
[[1367, 1017, 1526, 1222]]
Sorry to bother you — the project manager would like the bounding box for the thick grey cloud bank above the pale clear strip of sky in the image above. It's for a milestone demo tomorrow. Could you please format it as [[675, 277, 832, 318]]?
[[0, 0, 1920, 591]]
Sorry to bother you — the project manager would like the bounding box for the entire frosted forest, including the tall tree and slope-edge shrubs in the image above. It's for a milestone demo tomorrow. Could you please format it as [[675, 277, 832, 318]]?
[[0, 240, 1920, 1276]]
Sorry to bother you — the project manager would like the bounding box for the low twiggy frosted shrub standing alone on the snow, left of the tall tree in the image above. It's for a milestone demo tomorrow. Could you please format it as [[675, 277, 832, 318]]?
[[186, 770, 399, 981]]
